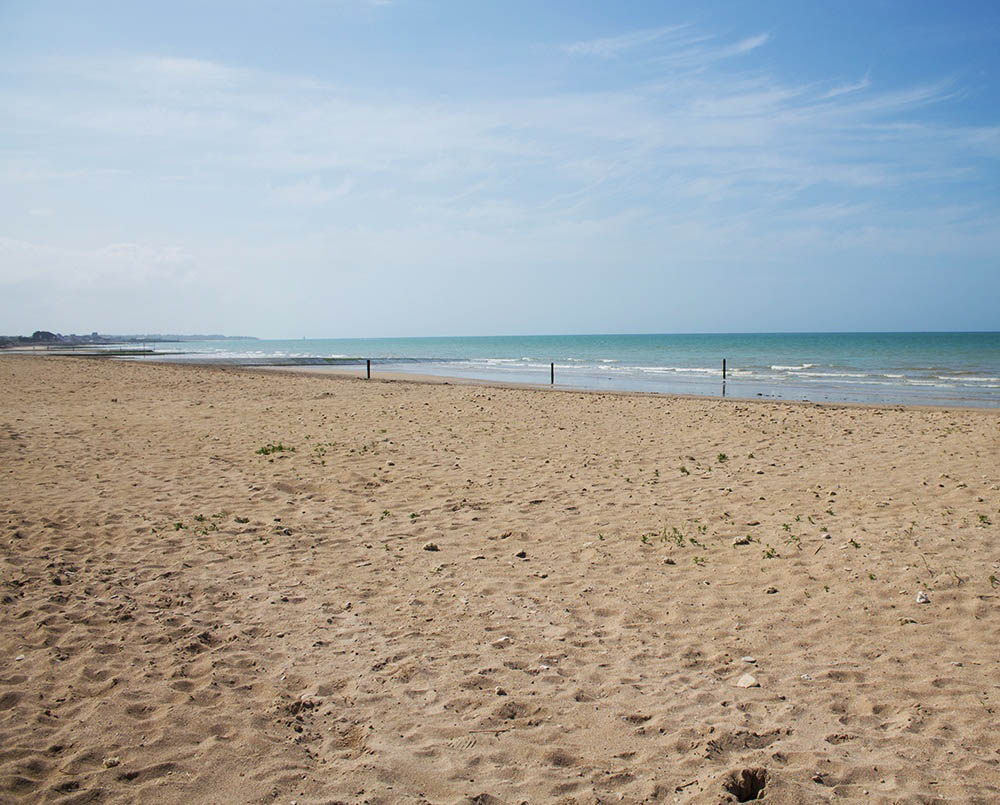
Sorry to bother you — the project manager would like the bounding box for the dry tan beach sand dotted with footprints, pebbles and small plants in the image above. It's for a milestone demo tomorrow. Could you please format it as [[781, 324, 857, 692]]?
[[0, 356, 1000, 803]]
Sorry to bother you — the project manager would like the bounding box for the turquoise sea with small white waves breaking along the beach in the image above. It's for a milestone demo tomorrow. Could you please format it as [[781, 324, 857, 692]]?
[[125, 332, 1000, 407]]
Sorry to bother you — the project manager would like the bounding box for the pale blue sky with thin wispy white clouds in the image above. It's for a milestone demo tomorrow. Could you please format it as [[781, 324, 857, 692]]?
[[0, 0, 1000, 338]]
